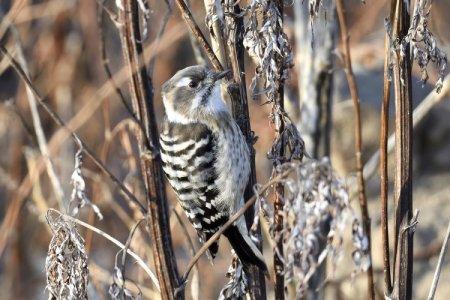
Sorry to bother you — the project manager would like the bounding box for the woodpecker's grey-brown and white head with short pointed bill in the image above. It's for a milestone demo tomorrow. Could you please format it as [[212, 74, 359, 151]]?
[[162, 65, 229, 123]]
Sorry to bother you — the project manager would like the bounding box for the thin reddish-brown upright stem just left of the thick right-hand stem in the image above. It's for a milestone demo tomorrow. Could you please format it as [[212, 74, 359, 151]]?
[[380, 34, 392, 295]]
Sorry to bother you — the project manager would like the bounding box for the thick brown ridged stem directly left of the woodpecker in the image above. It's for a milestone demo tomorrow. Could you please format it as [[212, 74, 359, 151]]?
[[120, 0, 184, 299]]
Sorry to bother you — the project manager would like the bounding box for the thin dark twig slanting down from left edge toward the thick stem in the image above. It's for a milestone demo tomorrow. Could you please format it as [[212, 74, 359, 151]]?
[[0, 45, 147, 215]]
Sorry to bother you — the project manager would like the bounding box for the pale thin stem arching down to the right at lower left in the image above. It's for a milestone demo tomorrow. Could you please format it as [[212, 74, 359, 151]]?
[[47, 208, 159, 290]]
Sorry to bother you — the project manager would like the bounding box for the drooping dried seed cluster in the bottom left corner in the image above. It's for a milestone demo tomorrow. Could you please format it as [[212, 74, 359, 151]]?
[[45, 218, 89, 300]]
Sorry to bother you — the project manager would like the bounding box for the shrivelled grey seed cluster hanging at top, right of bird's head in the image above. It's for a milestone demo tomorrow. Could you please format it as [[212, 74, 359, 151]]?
[[244, 0, 293, 101]]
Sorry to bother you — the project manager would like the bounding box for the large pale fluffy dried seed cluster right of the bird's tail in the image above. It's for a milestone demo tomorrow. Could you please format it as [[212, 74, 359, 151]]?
[[280, 158, 370, 295]]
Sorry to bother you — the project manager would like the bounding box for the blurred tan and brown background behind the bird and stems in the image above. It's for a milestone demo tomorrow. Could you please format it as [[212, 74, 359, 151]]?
[[0, 0, 450, 299]]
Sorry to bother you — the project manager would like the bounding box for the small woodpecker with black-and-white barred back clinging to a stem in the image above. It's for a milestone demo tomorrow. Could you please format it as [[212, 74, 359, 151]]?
[[160, 65, 267, 271]]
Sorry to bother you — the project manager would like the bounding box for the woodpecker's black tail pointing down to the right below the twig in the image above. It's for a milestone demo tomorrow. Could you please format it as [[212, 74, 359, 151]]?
[[224, 225, 267, 272]]
